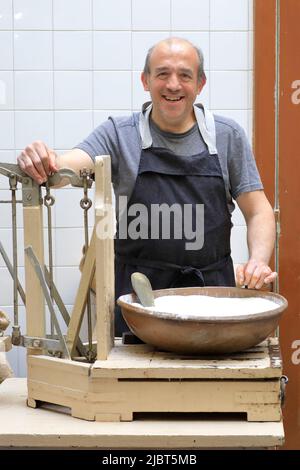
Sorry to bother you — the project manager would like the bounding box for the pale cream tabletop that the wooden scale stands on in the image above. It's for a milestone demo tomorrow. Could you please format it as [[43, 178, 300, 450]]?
[[0, 379, 284, 450]]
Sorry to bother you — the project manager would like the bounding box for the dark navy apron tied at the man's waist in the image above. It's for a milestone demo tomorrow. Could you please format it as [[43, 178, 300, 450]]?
[[115, 147, 235, 336]]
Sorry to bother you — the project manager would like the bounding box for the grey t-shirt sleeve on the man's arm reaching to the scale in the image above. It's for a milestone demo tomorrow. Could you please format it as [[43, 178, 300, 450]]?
[[75, 119, 119, 181]]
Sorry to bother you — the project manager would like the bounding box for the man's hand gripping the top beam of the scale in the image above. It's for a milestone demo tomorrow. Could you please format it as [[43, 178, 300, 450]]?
[[18, 140, 58, 184]]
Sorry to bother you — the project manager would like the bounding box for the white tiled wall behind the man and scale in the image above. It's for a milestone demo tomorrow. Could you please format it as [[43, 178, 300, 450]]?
[[0, 0, 253, 375]]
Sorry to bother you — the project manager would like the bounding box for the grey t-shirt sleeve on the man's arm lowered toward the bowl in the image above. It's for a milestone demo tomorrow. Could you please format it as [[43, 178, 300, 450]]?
[[228, 124, 263, 199]]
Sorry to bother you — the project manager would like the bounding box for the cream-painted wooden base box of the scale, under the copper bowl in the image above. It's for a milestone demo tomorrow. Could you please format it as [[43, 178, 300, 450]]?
[[28, 338, 282, 422]]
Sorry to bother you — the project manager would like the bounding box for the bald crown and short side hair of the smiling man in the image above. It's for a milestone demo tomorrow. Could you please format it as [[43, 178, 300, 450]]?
[[143, 37, 206, 82]]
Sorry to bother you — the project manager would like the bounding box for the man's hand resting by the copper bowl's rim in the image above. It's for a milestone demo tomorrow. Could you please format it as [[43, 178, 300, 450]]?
[[236, 259, 277, 289]]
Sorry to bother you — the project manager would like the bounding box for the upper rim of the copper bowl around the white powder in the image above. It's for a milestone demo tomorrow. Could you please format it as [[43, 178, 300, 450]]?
[[117, 286, 288, 323]]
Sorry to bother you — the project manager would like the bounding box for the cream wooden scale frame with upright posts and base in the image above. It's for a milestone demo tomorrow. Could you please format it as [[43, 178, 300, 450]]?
[[24, 156, 282, 421]]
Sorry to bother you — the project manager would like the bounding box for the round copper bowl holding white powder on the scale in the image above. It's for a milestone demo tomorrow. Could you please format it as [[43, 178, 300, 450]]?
[[117, 287, 288, 354]]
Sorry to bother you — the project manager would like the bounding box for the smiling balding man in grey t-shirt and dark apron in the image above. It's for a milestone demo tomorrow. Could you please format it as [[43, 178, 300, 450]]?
[[18, 38, 277, 335]]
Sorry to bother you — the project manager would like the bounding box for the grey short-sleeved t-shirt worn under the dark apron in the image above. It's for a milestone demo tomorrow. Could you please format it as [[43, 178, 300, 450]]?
[[76, 103, 263, 212]]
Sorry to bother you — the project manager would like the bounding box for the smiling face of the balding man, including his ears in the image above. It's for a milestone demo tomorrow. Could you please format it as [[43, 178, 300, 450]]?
[[141, 42, 205, 132]]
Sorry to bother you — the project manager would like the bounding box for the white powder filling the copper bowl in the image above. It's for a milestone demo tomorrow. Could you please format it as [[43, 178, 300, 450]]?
[[132, 295, 279, 318]]
